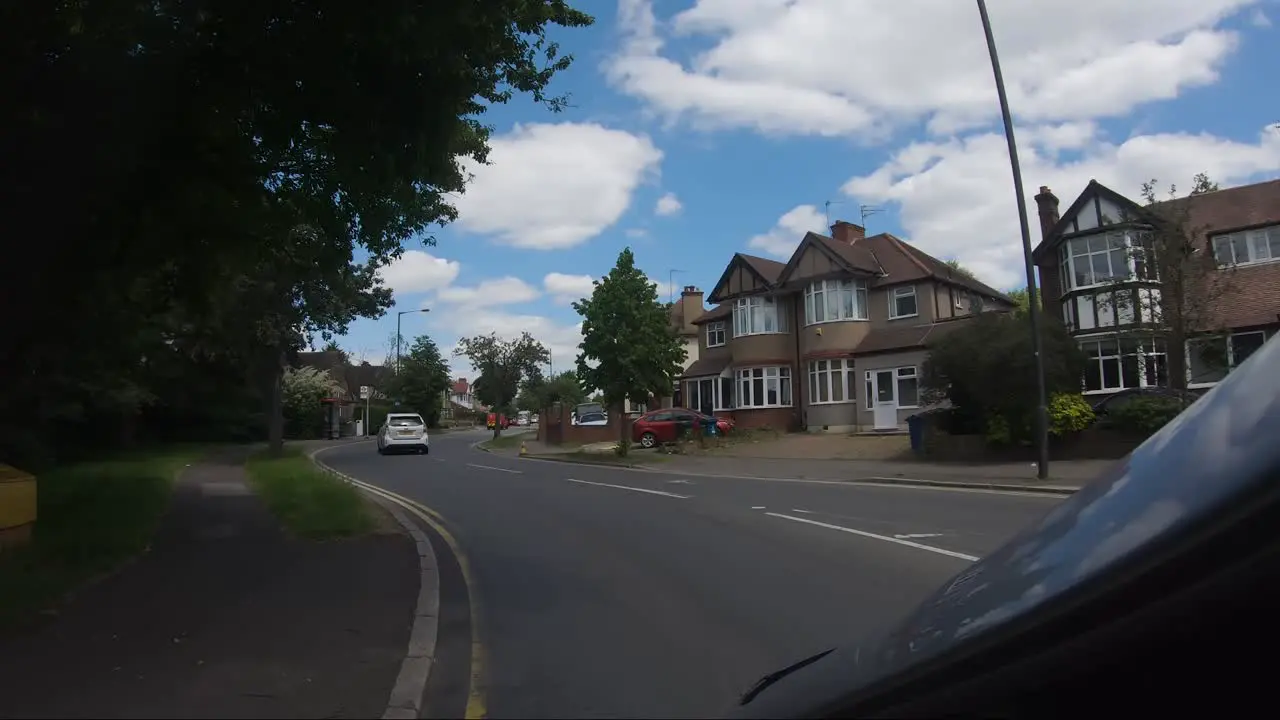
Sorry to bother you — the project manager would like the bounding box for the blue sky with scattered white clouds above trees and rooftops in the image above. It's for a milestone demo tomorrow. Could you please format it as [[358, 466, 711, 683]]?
[[339, 0, 1280, 377]]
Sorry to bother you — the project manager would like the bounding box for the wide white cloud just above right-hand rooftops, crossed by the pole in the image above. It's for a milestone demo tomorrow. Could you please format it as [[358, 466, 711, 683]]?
[[844, 127, 1280, 288]]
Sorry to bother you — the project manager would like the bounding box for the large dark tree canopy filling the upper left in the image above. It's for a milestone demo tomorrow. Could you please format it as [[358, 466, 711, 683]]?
[[0, 0, 591, 466]]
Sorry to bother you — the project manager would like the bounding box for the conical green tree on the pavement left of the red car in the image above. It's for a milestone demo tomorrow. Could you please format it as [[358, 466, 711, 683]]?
[[573, 247, 685, 455]]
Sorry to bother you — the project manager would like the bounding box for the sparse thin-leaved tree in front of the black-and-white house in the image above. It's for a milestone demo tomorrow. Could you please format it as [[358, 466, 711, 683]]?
[[1098, 173, 1234, 389]]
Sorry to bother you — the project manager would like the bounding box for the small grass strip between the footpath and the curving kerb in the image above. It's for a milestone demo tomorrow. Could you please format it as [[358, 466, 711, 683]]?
[[247, 447, 374, 539]]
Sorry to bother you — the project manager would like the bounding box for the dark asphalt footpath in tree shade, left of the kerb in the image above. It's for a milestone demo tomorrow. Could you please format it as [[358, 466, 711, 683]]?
[[0, 445, 419, 717]]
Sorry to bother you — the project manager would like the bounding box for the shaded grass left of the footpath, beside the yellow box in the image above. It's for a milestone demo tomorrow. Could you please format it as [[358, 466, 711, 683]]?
[[0, 446, 202, 628]]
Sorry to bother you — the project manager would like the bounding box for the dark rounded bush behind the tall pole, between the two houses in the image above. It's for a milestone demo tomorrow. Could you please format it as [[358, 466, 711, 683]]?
[[922, 313, 1084, 441]]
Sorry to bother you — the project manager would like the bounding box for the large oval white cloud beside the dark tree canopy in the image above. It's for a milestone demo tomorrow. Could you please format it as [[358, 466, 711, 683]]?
[[456, 123, 662, 250]]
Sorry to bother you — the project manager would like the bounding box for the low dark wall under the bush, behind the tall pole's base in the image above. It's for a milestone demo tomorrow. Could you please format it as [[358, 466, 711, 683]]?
[[920, 424, 1146, 462]]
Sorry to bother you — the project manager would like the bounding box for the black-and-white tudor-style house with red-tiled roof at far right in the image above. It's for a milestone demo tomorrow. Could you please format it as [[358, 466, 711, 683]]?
[[1033, 181, 1280, 396]]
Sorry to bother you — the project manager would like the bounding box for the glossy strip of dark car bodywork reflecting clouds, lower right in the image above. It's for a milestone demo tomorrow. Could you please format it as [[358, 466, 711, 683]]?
[[732, 333, 1280, 717]]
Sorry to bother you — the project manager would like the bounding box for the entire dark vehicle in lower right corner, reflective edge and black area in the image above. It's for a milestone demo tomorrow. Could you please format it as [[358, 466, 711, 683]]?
[[731, 340, 1280, 717]]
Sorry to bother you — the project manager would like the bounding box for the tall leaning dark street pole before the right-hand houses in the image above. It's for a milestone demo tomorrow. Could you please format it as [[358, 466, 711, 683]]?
[[977, 0, 1048, 480]]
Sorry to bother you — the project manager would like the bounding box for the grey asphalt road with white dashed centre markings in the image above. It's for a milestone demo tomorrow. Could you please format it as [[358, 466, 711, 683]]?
[[321, 432, 1059, 717]]
